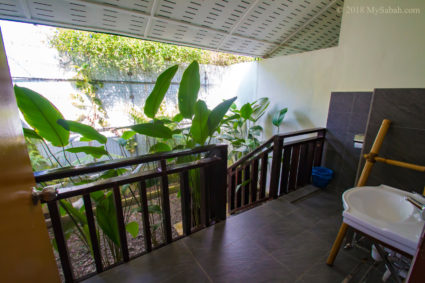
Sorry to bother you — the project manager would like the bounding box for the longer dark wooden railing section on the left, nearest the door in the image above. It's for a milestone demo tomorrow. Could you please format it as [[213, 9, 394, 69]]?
[[35, 145, 227, 282]]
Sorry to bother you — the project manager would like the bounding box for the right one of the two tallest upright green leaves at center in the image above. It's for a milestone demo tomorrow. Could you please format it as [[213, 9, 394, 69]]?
[[178, 61, 201, 119]]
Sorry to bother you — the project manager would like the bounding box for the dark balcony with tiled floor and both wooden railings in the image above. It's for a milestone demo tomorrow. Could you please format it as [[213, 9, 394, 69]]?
[[36, 128, 361, 282]]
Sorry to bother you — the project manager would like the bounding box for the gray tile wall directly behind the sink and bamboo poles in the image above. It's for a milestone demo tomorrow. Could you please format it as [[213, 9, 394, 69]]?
[[361, 89, 425, 193]]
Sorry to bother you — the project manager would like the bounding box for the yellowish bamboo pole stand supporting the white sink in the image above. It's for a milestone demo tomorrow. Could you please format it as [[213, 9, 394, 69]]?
[[326, 119, 425, 266]]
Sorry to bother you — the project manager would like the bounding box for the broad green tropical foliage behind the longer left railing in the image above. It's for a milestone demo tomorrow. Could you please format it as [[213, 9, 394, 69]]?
[[15, 61, 236, 266]]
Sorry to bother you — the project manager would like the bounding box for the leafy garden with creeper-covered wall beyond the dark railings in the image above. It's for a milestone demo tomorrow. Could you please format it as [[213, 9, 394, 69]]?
[[14, 27, 288, 277]]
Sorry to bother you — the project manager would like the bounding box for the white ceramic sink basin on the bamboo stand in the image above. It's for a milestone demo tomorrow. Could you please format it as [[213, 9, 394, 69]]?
[[342, 185, 424, 255]]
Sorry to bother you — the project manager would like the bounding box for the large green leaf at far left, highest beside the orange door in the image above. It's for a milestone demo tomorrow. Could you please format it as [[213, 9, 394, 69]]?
[[14, 86, 69, 146]]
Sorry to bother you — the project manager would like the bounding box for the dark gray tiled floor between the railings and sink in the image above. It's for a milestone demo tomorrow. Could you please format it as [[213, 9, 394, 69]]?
[[86, 191, 394, 283]]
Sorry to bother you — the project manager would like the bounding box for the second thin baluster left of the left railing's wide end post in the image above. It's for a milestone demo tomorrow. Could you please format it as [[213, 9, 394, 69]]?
[[160, 159, 173, 244]]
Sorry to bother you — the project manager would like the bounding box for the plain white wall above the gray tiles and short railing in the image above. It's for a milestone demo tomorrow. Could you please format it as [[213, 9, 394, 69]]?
[[238, 0, 425, 136]]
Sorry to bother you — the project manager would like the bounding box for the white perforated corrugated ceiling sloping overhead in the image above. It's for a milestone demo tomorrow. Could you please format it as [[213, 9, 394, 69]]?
[[0, 0, 344, 57]]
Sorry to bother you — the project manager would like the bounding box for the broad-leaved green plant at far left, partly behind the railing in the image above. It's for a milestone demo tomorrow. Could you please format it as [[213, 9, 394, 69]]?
[[14, 86, 138, 261]]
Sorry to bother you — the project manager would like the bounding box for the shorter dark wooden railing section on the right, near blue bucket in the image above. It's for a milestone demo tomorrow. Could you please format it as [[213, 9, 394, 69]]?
[[227, 128, 326, 213]]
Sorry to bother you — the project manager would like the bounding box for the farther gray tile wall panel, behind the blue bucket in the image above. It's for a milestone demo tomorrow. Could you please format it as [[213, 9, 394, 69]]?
[[324, 92, 372, 192]]
